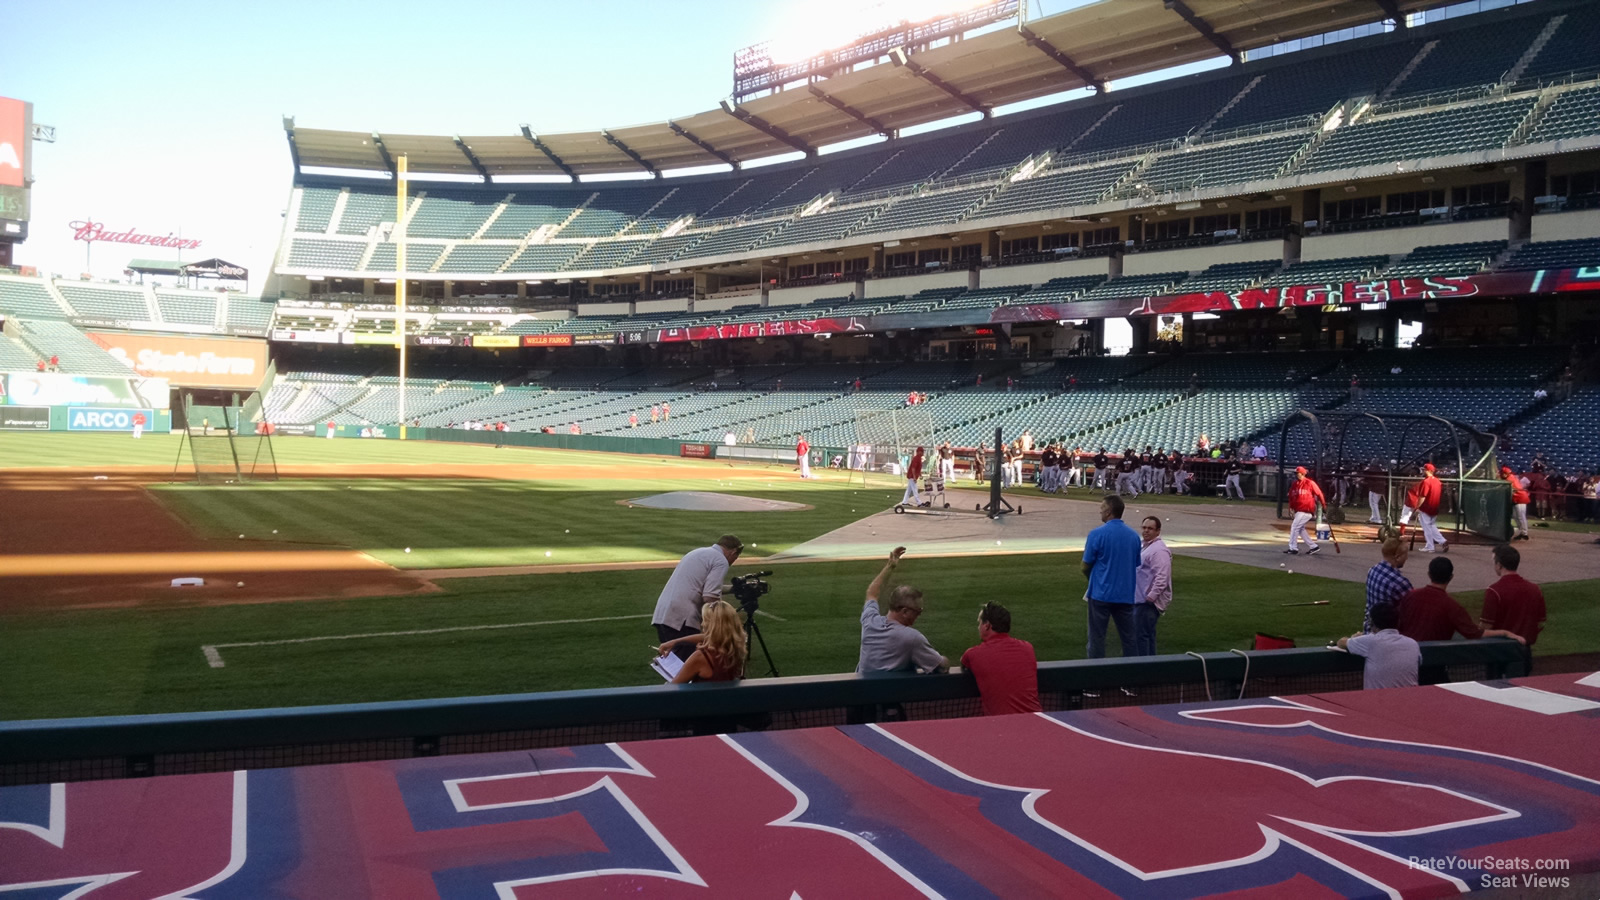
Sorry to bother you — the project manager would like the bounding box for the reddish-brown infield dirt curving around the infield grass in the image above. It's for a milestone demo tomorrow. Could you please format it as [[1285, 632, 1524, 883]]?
[[0, 458, 806, 613]]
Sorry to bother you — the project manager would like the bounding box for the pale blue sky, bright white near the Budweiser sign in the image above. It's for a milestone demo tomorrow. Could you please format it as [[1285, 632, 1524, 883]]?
[[0, 0, 1203, 290]]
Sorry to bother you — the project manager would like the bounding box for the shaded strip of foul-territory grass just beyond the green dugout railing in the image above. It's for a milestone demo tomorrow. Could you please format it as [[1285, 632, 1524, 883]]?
[[0, 554, 1600, 719]]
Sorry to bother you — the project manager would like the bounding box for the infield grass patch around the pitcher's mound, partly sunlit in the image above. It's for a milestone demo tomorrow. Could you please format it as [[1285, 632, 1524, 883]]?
[[154, 477, 928, 569]]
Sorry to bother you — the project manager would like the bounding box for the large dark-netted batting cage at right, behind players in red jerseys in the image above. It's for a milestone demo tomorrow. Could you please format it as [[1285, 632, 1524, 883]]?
[[1278, 410, 1510, 541]]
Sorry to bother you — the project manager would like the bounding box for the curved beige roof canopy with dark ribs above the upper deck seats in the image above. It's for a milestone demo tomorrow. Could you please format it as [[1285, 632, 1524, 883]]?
[[285, 0, 1438, 179]]
